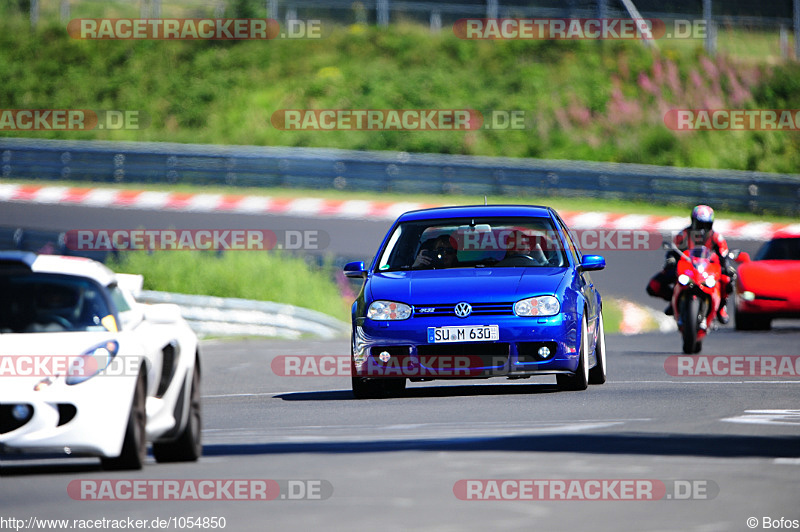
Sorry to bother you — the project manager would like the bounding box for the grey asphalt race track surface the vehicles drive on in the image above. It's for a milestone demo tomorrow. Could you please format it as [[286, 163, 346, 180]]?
[[0, 200, 800, 531]]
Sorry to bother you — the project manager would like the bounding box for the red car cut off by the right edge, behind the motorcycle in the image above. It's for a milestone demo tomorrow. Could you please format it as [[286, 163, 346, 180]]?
[[735, 233, 800, 331]]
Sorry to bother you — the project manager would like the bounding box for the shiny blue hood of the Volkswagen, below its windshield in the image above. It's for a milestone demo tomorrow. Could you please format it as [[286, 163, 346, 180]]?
[[369, 268, 569, 305]]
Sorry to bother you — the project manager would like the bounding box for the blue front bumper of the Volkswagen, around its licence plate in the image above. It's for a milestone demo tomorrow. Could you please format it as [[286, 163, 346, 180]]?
[[352, 313, 580, 380]]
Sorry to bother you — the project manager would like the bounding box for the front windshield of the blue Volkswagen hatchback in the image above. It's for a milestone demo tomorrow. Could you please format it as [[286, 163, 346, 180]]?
[[378, 217, 568, 271]]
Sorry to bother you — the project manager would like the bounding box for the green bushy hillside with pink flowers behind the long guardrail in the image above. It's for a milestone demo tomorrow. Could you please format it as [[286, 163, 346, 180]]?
[[0, 15, 800, 172]]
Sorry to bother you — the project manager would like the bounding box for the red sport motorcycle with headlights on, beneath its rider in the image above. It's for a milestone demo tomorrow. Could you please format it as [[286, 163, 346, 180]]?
[[672, 245, 730, 354]]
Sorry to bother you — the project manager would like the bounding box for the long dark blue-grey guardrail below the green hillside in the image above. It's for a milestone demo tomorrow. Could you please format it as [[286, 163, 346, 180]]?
[[0, 138, 800, 216]]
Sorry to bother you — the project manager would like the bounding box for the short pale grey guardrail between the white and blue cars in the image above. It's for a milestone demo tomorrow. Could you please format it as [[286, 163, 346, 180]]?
[[136, 290, 350, 339]]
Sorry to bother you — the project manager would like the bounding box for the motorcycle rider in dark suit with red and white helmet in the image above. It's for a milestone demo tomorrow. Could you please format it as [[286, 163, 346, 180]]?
[[647, 205, 736, 324]]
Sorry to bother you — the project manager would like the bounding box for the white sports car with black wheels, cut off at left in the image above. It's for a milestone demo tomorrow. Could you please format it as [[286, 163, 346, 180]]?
[[0, 251, 202, 469]]
